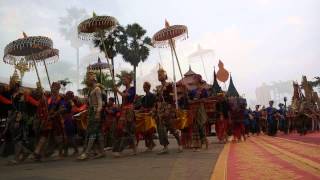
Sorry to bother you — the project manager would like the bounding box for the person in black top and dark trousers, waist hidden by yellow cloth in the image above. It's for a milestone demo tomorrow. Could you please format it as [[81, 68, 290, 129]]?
[[140, 82, 156, 151]]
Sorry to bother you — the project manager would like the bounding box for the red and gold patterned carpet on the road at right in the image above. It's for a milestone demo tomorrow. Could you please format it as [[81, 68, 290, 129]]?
[[211, 136, 320, 180]]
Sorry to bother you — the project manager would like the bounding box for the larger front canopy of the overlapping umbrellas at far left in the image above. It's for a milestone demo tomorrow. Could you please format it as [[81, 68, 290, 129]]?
[[3, 33, 53, 65]]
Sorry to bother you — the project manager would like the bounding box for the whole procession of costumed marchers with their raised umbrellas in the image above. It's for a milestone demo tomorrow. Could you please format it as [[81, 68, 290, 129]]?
[[0, 13, 320, 164]]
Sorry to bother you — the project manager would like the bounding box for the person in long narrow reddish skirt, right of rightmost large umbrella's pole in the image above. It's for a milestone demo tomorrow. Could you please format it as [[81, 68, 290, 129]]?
[[190, 76, 208, 151]]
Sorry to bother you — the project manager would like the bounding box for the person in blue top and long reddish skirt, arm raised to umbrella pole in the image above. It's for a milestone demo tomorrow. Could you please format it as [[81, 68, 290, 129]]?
[[112, 73, 137, 157]]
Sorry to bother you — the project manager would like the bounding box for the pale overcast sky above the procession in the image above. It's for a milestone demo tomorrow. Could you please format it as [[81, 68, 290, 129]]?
[[0, 0, 320, 102]]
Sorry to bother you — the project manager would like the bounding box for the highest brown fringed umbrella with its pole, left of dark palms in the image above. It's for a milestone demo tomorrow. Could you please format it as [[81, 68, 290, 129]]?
[[78, 13, 118, 101]]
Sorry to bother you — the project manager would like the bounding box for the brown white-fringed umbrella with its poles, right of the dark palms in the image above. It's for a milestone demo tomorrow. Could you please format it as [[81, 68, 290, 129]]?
[[152, 21, 188, 109]]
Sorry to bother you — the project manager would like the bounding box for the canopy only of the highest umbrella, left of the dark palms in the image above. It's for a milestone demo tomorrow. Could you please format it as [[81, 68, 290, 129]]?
[[78, 13, 119, 40]]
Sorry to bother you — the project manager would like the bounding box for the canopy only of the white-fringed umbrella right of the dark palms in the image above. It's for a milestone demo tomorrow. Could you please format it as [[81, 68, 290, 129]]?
[[152, 20, 188, 47]]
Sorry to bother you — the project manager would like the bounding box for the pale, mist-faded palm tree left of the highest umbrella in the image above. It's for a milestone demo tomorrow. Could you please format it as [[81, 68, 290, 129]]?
[[59, 7, 88, 89]]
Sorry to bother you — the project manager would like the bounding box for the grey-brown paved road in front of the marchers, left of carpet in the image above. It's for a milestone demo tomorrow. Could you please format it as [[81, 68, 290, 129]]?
[[0, 138, 223, 180]]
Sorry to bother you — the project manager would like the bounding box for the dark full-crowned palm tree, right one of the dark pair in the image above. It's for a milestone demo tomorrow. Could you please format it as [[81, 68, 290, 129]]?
[[118, 23, 151, 87]]
